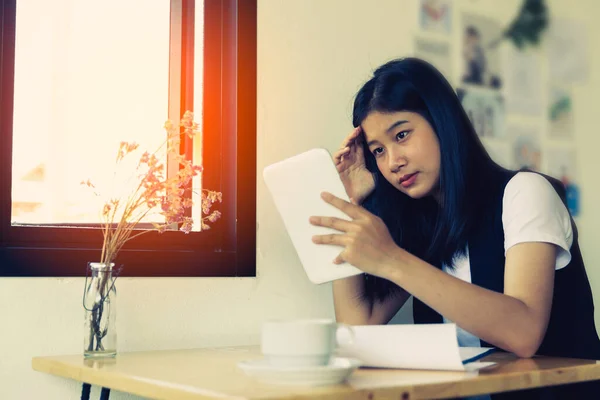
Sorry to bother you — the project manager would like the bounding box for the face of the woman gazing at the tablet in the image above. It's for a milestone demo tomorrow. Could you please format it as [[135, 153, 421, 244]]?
[[361, 111, 440, 200]]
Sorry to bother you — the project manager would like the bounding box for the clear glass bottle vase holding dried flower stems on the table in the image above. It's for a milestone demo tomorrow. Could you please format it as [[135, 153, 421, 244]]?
[[83, 263, 117, 358]]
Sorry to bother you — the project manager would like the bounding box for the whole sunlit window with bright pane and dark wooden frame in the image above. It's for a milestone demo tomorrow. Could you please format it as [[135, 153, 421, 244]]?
[[0, 0, 256, 276]]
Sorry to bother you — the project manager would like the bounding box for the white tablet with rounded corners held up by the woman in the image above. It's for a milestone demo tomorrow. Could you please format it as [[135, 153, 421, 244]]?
[[263, 149, 362, 284]]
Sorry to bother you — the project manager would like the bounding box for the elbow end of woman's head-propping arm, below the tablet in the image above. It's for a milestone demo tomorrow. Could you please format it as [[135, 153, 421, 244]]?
[[333, 275, 410, 325]]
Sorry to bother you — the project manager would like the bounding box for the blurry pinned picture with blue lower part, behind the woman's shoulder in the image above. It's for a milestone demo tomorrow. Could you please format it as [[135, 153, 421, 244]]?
[[547, 148, 579, 217]]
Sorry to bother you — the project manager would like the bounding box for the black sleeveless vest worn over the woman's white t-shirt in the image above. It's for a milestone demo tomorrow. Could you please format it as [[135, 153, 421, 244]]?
[[413, 172, 600, 399]]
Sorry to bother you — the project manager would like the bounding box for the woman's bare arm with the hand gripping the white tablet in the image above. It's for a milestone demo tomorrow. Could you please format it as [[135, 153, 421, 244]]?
[[311, 193, 557, 357]]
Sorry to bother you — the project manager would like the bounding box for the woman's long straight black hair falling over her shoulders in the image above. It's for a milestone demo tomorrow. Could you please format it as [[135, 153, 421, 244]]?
[[352, 58, 505, 300]]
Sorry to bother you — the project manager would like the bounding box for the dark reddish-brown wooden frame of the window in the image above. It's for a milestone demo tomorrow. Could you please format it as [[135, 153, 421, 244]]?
[[0, 0, 256, 277]]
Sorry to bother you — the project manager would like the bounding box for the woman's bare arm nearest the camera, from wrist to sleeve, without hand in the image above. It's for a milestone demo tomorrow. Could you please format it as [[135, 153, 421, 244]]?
[[381, 242, 556, 357]]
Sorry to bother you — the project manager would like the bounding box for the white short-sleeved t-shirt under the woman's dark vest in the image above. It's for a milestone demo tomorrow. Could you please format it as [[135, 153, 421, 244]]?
[[443, 172, 573, 347]]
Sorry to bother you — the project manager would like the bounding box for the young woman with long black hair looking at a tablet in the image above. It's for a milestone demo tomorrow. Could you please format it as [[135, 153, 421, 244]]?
[[311, 58, 600, 398]]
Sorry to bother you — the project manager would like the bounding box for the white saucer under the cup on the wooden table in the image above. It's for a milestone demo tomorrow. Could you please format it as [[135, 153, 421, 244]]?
[[238, 357, 361, 386]]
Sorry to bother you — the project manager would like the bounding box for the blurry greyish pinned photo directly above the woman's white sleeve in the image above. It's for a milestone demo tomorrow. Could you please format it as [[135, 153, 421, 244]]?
[[508, 125, 542, 172]]
